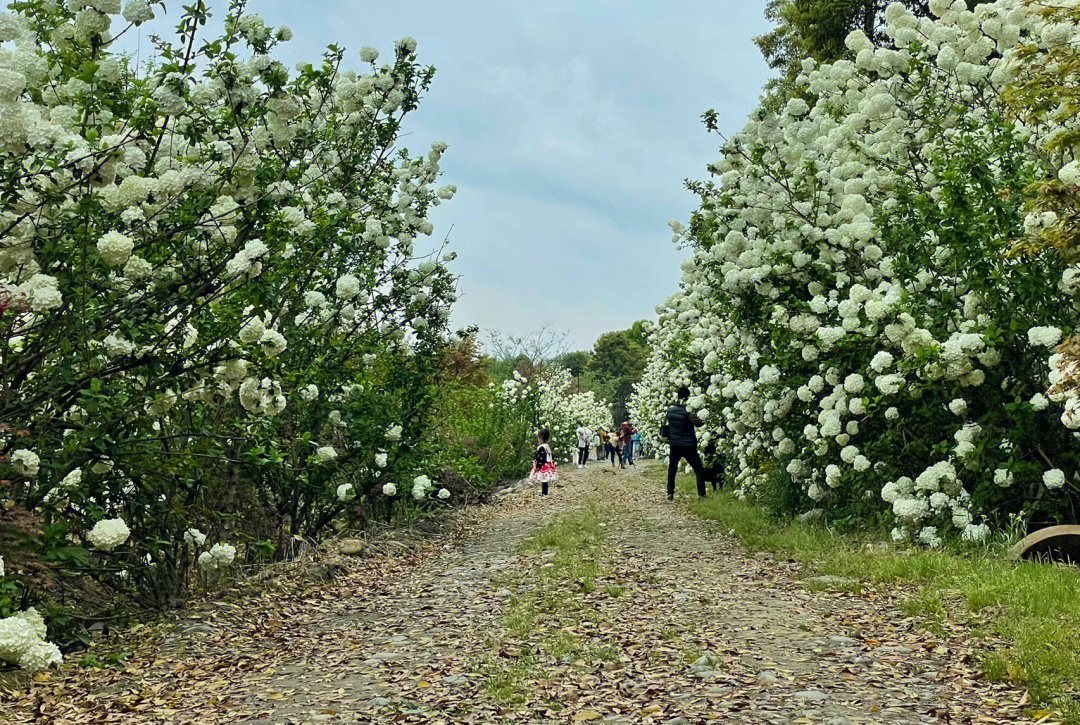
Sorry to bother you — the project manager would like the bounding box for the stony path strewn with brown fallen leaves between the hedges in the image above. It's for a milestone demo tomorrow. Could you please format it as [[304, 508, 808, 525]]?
[[8, 464, 1022, 725]]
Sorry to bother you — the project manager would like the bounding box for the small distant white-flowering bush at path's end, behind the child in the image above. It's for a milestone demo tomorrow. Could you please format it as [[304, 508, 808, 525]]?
[[498, 365, 612, 460]]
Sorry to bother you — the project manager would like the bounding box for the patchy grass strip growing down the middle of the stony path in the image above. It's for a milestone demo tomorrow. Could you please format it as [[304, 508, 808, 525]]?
[[480, 506, 622, 710]]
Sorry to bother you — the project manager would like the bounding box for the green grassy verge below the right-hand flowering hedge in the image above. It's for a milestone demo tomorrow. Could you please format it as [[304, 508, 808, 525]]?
[[679, 471, 1080, 725]]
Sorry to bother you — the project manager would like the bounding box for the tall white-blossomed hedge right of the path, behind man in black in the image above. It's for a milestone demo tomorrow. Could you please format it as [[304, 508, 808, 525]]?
[[632, 0, 1080, 546]]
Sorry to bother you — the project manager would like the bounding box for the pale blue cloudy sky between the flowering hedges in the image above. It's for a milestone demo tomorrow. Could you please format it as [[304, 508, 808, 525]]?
[[124, 0, 769, 348]]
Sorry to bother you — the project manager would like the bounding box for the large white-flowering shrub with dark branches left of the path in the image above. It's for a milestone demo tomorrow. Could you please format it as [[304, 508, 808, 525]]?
[[0, 0, 473, 663]]
